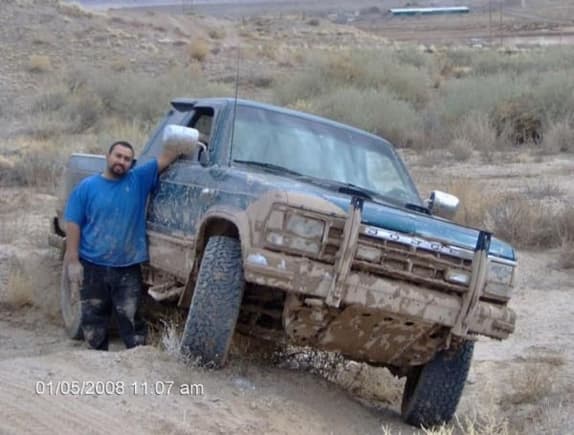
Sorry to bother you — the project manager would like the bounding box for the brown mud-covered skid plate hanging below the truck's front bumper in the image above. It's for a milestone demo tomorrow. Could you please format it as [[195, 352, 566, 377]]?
[[284, 294, 448, 367]]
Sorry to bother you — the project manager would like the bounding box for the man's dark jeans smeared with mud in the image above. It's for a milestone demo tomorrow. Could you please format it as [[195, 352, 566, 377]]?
[[80, 260, 146, 350]]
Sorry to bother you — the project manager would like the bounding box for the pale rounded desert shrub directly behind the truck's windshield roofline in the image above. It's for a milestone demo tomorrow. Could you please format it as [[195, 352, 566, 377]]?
[[310, 88, 422, 146]]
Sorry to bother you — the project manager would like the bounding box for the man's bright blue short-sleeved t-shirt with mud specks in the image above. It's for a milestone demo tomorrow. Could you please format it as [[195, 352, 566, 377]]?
[[65, 159, 158, 267]]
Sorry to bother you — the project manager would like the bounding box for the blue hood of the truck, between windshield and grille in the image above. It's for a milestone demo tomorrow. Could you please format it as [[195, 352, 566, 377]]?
[[241, 171, 516, 261]]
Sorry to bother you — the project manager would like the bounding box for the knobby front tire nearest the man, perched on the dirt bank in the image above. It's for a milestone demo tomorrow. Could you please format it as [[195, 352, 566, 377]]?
[[181, 236, 245, 367]]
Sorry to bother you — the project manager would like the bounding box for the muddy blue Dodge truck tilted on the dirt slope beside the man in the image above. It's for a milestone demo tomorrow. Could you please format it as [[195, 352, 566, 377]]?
[[51, 99, 516, 426]]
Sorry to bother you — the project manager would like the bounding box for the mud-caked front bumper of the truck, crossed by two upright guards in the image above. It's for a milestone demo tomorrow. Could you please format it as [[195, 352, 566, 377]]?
[[244, 248, 516, 339]]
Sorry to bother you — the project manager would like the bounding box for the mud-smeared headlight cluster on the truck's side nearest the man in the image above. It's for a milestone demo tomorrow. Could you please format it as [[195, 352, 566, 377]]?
[[265, 213, 325, 255]]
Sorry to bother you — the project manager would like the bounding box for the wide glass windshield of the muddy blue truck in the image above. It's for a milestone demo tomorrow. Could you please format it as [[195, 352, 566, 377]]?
[[232, 106, 420, 204]]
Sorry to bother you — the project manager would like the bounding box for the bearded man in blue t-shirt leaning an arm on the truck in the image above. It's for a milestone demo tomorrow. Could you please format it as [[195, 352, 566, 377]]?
[[65, 133, 197, 350]]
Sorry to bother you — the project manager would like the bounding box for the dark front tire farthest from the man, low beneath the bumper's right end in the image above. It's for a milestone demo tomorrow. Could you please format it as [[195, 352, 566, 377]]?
[[401, 341, 474, 428]]
